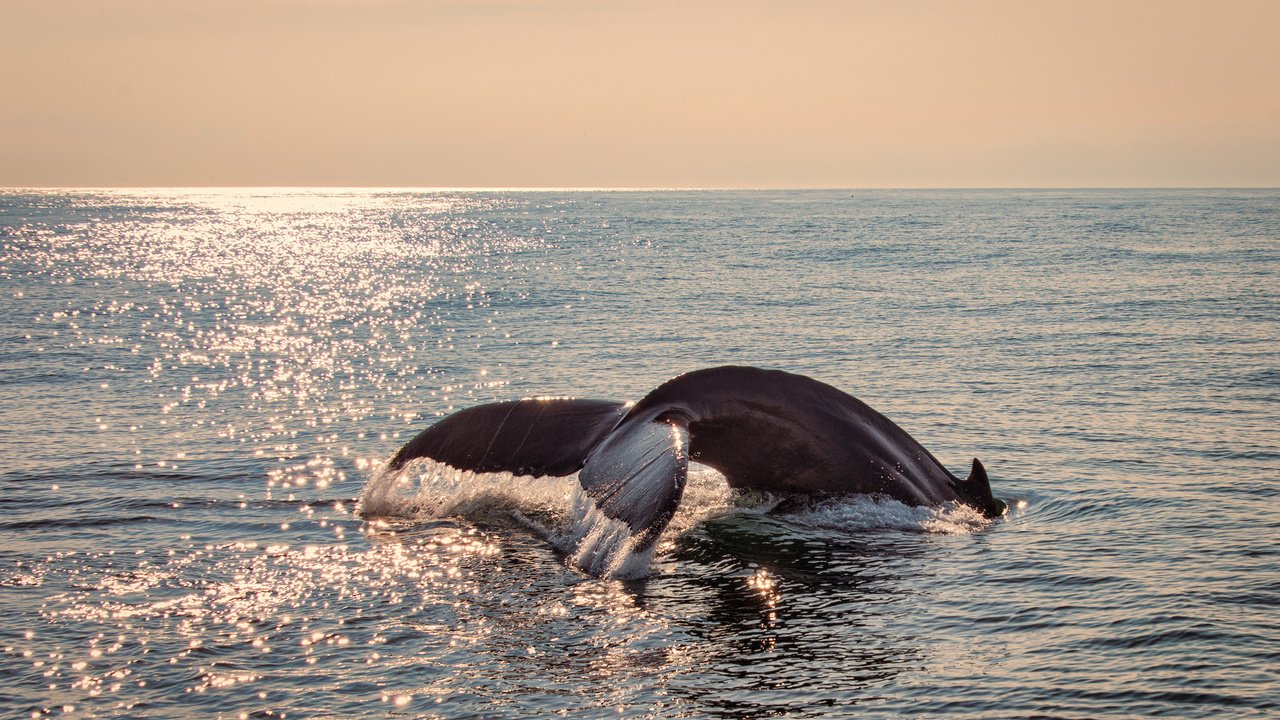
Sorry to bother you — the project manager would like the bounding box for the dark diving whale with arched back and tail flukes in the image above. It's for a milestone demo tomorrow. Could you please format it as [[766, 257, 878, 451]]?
[[387, 365, 1006, 563]]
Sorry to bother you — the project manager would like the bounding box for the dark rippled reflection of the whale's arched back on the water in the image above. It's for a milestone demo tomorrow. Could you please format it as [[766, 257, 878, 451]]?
[[654, 516, 923, 717]]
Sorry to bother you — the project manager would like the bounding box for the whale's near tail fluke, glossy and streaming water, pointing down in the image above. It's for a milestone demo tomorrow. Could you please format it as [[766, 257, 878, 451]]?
[[579, 419, 689, 551]]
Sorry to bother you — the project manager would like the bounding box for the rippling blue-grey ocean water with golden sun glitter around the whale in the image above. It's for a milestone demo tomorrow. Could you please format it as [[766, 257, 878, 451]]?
[[0, 190, 1280, 717]]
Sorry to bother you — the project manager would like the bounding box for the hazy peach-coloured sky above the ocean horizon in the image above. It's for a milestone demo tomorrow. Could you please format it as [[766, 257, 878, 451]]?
[[0, 0, 1280, 187]]
